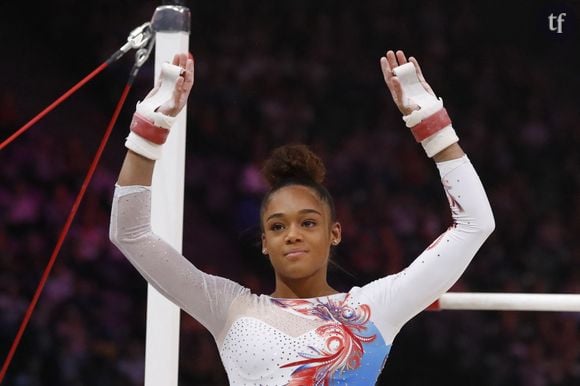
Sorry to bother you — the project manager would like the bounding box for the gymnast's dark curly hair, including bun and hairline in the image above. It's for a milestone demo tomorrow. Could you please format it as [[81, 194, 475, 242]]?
[[260, 144, 336, 227]]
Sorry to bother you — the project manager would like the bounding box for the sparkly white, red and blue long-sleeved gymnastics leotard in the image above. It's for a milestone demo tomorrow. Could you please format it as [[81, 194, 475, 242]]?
[[110, 156, 494, 386]]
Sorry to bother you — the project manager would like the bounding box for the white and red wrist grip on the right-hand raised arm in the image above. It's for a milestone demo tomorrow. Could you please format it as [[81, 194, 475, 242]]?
[[393, 62, 459, 157]]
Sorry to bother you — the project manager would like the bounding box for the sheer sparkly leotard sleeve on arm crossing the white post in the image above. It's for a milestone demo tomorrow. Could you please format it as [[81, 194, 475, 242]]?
[[109, 186, 248, 336]]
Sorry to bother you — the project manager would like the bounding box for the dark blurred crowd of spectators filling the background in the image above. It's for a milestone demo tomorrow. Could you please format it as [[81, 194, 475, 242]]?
[[0, 0, 580, 386]]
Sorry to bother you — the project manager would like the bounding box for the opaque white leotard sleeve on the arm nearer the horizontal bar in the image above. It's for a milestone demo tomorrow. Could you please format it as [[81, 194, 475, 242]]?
[[361, 156, 495, 335]]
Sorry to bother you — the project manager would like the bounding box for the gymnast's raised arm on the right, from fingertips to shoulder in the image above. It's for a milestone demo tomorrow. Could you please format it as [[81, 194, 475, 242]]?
[[362, 51, 495, 336]]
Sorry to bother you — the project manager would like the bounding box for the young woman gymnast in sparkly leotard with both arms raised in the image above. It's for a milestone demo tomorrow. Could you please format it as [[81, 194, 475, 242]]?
[[110, 51, 494, 385]]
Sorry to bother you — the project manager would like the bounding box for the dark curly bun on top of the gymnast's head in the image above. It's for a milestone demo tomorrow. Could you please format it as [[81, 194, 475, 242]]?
[[262, 144, 326, 187]]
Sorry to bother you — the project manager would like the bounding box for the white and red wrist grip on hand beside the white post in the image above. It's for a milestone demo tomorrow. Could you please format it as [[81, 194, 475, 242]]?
[[125, 63, 183, 160]]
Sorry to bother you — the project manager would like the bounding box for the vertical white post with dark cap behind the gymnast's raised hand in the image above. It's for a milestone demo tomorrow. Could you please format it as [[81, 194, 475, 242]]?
[[145, 5, 189, 386]]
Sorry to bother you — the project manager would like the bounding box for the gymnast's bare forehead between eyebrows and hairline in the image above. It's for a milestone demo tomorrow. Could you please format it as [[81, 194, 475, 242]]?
[[264, 185, 327, 217]]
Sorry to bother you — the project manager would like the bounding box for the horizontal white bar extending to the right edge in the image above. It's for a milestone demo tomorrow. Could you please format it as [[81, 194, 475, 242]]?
[[436, 292, 580, 312]]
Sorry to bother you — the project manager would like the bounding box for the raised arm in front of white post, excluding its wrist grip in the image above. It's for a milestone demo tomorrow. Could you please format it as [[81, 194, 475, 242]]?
[[109, 55, 248, 335]]
